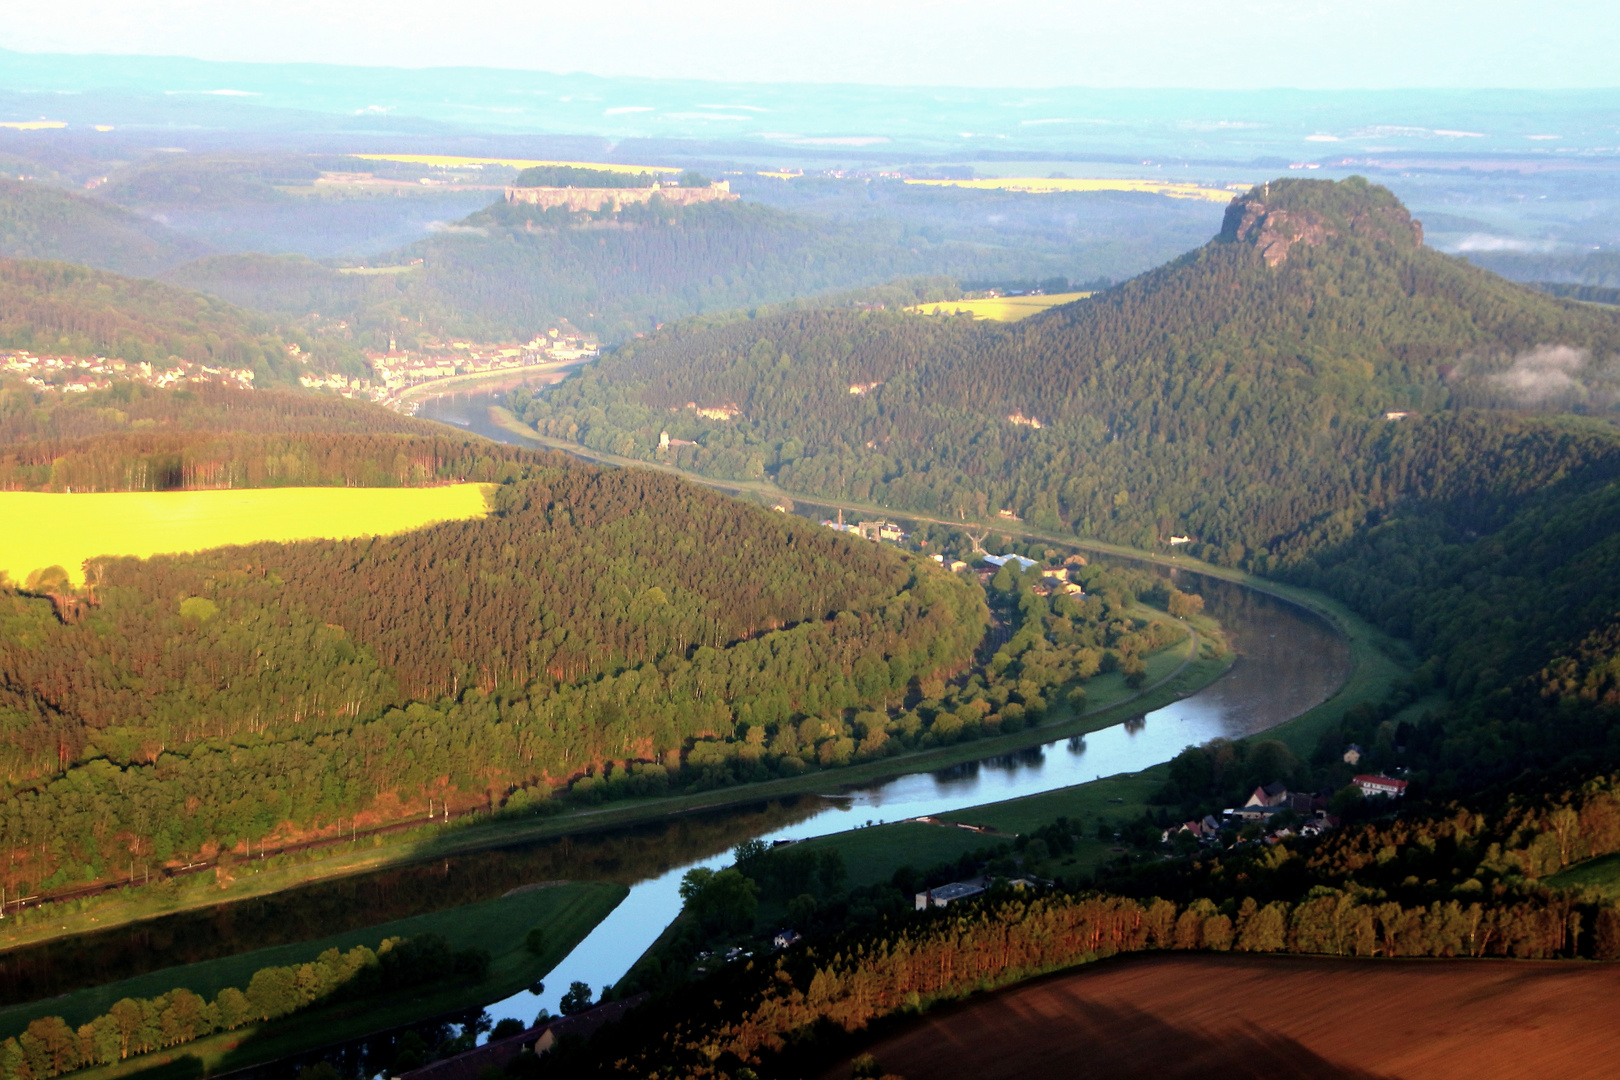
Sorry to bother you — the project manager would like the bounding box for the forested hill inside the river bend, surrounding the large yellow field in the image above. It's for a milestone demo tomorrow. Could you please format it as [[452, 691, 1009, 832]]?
[[0, 383, 987, 891]]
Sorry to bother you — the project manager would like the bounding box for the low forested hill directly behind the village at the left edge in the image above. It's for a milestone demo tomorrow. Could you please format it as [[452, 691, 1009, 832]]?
[[0, 259, 347, 382]]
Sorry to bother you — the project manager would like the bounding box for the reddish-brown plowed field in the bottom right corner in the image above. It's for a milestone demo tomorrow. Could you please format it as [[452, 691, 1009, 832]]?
[[823, 955, 1620, 1080]]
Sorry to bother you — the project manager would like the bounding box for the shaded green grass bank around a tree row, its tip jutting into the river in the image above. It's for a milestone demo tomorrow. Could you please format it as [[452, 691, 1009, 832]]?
[[0, 882, 629, 1080]]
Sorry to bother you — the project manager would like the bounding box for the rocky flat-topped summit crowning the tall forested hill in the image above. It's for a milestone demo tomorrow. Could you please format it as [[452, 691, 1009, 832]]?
[[1220, 176, 1422, 267]]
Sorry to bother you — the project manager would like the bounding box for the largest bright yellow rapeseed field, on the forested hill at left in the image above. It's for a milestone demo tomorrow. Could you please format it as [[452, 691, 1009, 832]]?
[[0, 484, 492, 585]]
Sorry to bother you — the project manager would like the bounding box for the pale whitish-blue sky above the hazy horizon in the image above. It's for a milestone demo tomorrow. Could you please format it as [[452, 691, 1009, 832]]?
[[9, 0, 1620, 89]]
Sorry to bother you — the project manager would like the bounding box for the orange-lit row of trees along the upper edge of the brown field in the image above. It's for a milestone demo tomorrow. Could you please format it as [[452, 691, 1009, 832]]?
[[570, 894, 1620, 1078]]
